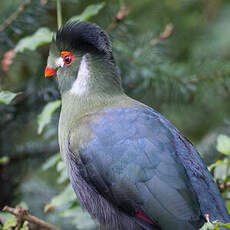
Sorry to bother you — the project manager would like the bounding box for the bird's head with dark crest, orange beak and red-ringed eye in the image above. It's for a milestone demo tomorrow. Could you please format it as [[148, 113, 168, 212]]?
[[45, 22, 121, 95]]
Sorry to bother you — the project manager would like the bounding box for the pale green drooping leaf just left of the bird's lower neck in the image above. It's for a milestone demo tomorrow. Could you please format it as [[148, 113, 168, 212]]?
[[38, 100, 61, 134]]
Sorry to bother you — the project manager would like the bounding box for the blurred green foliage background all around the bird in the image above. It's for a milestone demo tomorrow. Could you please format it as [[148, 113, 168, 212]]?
[[0, 0, 230, 230]]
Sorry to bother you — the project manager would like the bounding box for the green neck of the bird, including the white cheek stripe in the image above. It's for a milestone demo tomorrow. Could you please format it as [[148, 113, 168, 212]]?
[[61, 56, 125, 125]]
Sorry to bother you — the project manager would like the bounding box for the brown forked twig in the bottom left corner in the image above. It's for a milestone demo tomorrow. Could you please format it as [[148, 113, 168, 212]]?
[[2, 206, 60, 230]]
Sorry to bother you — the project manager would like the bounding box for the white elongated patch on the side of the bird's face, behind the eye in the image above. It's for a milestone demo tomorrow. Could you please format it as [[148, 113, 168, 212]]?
[[70, 56, 90, 95]]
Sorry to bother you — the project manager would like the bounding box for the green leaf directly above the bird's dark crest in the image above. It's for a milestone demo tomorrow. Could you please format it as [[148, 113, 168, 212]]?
[[69, 2, 105, 21]]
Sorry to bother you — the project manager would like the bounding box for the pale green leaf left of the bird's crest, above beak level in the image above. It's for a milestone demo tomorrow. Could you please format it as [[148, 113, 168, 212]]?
[[14, 27, 52, 52]]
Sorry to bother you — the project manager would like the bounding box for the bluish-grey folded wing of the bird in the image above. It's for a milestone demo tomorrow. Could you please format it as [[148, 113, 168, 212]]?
[[70, 107, 228, 230]]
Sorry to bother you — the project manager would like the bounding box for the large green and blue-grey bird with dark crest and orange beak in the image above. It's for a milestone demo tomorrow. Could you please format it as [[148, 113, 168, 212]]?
[[45, 21, 230, 230]]
